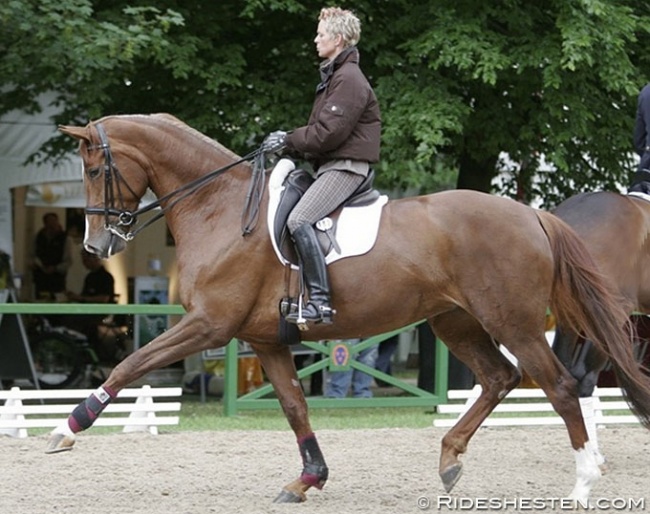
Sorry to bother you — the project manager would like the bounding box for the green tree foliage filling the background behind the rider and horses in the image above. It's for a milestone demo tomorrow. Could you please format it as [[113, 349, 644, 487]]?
[[0, 0, 650, 205]]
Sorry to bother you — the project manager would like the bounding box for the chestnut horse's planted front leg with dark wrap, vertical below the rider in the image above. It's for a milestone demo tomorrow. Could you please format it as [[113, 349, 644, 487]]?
[[252, 344, 329, 503]]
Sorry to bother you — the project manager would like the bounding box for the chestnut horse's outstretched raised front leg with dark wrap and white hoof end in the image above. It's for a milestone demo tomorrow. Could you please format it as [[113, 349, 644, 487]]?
[[45, 314, 218, 453]]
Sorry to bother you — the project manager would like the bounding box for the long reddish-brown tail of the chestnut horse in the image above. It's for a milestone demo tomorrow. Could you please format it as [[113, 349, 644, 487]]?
[[537, 211, 650, 429]]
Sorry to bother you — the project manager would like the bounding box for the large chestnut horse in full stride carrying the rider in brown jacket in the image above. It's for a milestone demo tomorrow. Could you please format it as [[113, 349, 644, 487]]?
[[52, 114, 650, 502]]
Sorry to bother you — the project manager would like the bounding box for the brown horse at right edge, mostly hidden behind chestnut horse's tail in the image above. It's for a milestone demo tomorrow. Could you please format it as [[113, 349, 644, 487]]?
[[553, 191, 650, 465]]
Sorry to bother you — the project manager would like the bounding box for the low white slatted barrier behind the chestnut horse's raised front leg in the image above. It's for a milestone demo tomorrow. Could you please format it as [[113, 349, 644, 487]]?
[[0, 385, 183, 438]]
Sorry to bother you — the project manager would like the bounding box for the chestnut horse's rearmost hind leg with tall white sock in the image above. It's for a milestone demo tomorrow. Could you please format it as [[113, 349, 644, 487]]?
[[502, 334, 601, 505]]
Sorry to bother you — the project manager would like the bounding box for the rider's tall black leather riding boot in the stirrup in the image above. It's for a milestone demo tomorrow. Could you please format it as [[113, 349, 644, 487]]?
[[286, 223, 335, 323]]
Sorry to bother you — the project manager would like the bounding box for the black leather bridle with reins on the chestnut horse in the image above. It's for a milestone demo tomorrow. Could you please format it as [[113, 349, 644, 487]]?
[[85, 123, 264, 242]]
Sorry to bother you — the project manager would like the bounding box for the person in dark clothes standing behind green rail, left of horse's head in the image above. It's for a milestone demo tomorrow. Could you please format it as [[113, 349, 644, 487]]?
[[32, 212, 72, 301]]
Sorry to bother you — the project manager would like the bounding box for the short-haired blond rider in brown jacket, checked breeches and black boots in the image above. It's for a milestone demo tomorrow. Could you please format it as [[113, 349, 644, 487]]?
[[262, 7, 381, 323]]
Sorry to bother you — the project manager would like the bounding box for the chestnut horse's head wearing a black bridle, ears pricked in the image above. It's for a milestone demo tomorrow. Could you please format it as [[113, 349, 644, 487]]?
[[59, 118, 149, 258]]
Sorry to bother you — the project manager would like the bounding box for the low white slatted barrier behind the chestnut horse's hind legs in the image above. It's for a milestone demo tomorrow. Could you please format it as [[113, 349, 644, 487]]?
[[433, 385, 639, 427]]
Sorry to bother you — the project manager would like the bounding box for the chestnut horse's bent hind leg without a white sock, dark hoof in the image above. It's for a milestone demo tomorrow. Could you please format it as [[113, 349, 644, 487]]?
[[430, 309, 521, 492]]
